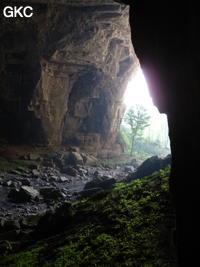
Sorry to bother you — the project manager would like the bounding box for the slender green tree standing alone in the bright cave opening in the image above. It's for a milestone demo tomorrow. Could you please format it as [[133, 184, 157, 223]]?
[[124, 105, 150, 156]]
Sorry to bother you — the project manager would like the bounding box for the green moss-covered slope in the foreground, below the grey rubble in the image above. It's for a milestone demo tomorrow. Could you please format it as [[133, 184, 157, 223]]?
[[0, 169, 176, 267]]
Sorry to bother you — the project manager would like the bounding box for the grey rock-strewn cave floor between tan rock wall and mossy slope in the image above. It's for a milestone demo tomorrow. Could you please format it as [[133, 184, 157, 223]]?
[[0, 151, 138, 225]]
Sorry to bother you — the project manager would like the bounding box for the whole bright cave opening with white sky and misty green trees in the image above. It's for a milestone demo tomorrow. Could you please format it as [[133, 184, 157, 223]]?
[[121, 67, 170, 159]]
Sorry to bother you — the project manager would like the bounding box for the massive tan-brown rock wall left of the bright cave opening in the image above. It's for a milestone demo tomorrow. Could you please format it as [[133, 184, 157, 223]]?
[[0, 0, 138, 155]]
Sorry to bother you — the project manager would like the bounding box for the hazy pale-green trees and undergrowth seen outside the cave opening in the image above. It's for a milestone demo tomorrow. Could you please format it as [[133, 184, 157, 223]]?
[[120, 105, 170, 159]]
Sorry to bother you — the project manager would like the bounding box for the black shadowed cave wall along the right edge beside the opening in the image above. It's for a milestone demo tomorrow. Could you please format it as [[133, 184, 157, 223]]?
[[124, 1, 200, 266]]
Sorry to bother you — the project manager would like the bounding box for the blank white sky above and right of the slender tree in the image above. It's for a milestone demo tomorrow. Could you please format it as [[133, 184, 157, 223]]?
[[124, 68, 169, 149]]
